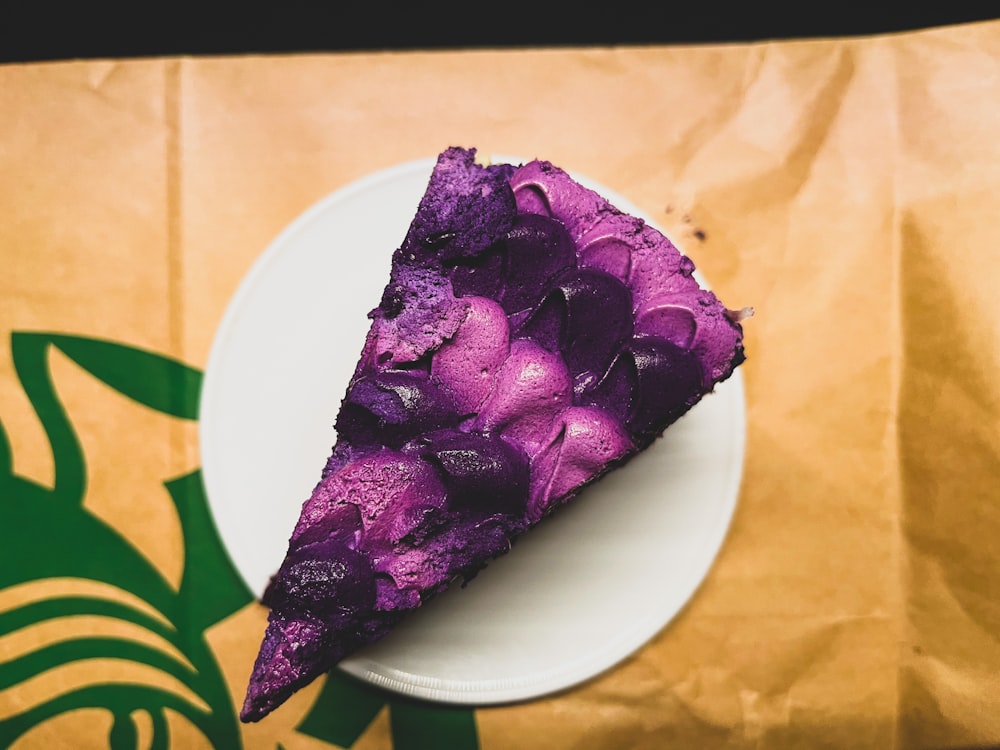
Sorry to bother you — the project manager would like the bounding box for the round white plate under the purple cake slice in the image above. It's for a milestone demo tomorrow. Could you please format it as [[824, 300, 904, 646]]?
[[200, 159, 745, 704]]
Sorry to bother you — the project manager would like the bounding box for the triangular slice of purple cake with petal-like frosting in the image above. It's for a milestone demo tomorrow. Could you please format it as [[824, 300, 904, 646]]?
[[241, 148, 743, 721]]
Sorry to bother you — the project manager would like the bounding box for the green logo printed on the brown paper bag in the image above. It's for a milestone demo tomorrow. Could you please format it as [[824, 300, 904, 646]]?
[[0, 333, 479, 750]]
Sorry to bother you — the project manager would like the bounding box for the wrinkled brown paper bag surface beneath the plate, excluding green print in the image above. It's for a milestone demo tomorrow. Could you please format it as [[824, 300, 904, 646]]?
[[0, 17, 1000, 750]]
